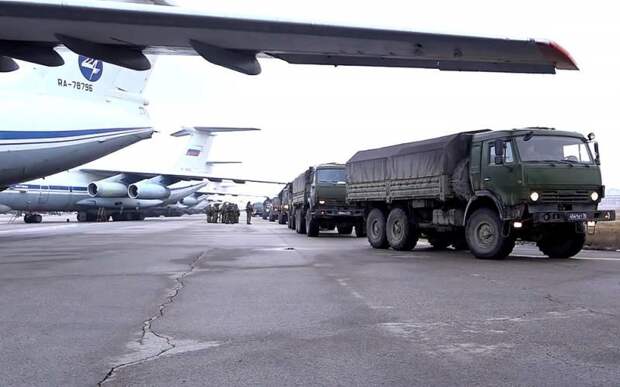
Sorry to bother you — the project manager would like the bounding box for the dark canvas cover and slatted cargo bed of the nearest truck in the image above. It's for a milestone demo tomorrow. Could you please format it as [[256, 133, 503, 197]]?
[[346, 132, 474, 201]]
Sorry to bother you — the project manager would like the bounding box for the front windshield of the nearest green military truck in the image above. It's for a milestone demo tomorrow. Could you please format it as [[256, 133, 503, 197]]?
[[517, 136, 592, 164]]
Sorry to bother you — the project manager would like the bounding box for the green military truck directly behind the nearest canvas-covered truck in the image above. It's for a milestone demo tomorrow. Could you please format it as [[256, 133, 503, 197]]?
[[291, 164, 365, 237]]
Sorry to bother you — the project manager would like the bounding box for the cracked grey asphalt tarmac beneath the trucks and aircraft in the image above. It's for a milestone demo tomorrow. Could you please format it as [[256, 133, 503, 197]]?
[[0, 216, 620, 386]]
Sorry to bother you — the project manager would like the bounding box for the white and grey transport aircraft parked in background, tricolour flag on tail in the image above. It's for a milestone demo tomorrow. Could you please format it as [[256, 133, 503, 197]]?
[[0, 127, 283, 223]]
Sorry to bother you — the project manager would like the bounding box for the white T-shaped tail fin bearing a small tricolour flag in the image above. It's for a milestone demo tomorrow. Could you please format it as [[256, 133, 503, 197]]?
[[171, 126, 260, 174]]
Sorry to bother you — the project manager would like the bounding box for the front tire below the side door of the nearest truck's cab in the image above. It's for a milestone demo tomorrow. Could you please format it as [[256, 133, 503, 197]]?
[[465, 208, 515, 259]]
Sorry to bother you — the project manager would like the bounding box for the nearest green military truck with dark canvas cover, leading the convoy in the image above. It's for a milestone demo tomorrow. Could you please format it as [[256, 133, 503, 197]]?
[[346, 128, 615, 259]]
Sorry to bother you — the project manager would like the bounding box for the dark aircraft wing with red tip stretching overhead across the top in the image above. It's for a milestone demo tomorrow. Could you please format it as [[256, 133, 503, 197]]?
[[0, 0, 578, 75]]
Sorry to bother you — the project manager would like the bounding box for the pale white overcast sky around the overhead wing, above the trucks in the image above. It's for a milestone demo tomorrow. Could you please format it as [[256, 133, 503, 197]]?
[[88, 0, 620, 197]]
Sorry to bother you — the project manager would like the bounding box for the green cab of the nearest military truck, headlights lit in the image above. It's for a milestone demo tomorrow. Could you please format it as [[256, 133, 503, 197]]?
[[465, 128, 615, 257]]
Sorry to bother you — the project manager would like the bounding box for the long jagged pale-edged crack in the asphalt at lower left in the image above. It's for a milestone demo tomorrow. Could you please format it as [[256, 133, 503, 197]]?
[[97, 253, 206, 386]]
